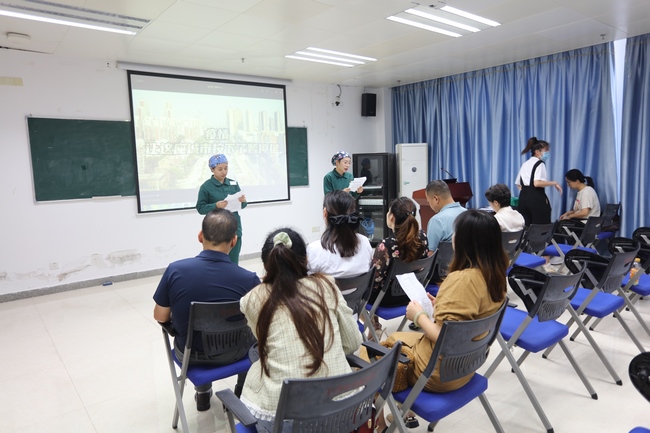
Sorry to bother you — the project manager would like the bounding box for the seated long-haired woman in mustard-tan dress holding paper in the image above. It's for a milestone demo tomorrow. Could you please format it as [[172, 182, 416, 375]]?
[[377, 210, 508, 431]]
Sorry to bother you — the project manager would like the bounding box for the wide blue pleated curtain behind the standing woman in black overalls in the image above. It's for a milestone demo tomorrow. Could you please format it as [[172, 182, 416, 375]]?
[[392, 43, 618, 218]]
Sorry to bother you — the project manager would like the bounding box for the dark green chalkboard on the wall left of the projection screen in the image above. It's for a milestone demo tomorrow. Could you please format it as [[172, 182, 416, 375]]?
[[27, 117, 135, 201]]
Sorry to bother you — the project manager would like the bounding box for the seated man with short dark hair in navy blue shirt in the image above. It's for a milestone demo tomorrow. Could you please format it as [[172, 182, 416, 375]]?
[[153, 209, 260, 411]]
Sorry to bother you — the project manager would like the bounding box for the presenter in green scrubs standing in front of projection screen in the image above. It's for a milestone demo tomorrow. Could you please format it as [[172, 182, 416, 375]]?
[[196, 153, 247, 265]]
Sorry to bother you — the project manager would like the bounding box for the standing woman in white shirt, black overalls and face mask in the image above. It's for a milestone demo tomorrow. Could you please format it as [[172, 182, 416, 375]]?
[[515, 137, 562, 226]]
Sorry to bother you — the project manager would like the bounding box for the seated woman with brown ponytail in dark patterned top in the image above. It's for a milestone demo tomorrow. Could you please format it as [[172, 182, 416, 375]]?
[[370, 197, 429, 307]]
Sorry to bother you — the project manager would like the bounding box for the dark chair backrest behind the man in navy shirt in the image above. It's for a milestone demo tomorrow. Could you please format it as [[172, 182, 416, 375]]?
[[185, 301, 255, 358]]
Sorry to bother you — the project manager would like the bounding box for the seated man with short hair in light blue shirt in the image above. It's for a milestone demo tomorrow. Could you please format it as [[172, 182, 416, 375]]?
[[426, 180, 467, 251]]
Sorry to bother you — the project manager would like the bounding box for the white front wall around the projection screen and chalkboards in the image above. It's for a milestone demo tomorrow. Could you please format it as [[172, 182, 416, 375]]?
[[0, 50, 390, 296]]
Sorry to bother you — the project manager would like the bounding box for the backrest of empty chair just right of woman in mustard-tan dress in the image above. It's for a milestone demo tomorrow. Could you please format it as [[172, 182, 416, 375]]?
[[508, 265, 586, 322]]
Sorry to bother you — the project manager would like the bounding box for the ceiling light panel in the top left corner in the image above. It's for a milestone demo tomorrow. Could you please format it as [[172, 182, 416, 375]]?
[[0, 0, 149, 35]]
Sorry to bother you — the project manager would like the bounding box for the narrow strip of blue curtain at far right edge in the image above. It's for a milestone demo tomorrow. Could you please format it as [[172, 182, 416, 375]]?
[[621, 34, 650, 237]]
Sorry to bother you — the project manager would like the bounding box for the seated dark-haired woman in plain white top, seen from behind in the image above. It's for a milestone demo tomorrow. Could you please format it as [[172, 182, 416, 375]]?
[[307, 191, 372, 278]]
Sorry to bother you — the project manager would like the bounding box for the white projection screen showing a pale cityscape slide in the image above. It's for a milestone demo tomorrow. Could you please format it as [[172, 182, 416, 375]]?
[[128, 71, 290, 213]]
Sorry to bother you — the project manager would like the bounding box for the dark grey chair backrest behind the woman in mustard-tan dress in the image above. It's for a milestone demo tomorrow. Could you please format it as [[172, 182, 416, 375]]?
[[422, 298, 508, 382]]
